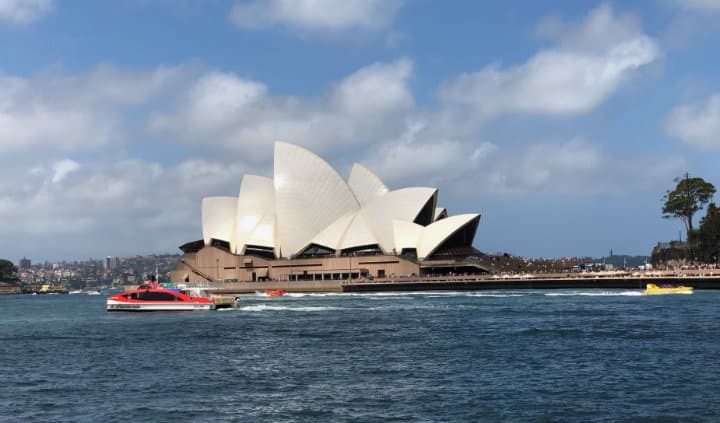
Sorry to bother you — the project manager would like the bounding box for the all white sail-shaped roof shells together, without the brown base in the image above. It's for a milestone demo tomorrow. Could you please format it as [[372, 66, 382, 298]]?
[[195, 142, 480, 259]]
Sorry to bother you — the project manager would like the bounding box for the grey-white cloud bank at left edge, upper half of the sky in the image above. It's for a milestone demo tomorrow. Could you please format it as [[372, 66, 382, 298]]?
[[0, 65, 185, 152]]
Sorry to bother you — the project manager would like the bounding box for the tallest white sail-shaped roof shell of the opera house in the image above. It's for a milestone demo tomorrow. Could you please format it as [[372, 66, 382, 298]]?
[[274, 142, 359, 257]]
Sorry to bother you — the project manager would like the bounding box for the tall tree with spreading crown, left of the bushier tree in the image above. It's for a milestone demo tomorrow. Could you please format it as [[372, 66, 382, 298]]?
[[663, 174, 715, 234]]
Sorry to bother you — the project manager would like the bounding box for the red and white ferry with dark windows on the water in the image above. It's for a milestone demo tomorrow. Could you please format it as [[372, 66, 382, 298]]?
[[107, 282, 215, 311]]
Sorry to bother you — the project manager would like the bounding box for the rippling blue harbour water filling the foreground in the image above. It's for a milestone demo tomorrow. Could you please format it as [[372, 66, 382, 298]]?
[[0, 290, 720, 422]]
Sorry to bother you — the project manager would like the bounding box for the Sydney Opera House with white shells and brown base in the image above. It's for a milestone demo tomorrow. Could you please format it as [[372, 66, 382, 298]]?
[[171, 142, 483, 282]]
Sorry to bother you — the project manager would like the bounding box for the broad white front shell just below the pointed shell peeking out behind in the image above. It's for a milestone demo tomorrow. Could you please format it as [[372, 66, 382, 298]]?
[[362, 187, 437, 253]]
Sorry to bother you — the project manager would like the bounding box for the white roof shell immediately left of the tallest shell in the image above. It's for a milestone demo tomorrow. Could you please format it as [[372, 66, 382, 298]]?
[[233, 175, 275, 254]]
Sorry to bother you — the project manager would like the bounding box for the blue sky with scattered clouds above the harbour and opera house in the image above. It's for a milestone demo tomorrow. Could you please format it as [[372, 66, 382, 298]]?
[[0, 0, 720, 261]]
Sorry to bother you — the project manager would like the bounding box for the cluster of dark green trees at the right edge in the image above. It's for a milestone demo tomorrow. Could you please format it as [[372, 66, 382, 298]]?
[[662, 174, 720, 263]]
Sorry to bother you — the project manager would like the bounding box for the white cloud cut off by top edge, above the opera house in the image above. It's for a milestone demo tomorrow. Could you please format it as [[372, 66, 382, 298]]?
[[230, 0, 404, 32]]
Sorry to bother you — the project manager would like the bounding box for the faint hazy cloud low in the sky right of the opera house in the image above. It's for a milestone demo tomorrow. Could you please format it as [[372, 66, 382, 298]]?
[[458, 138, 685, 198]]
